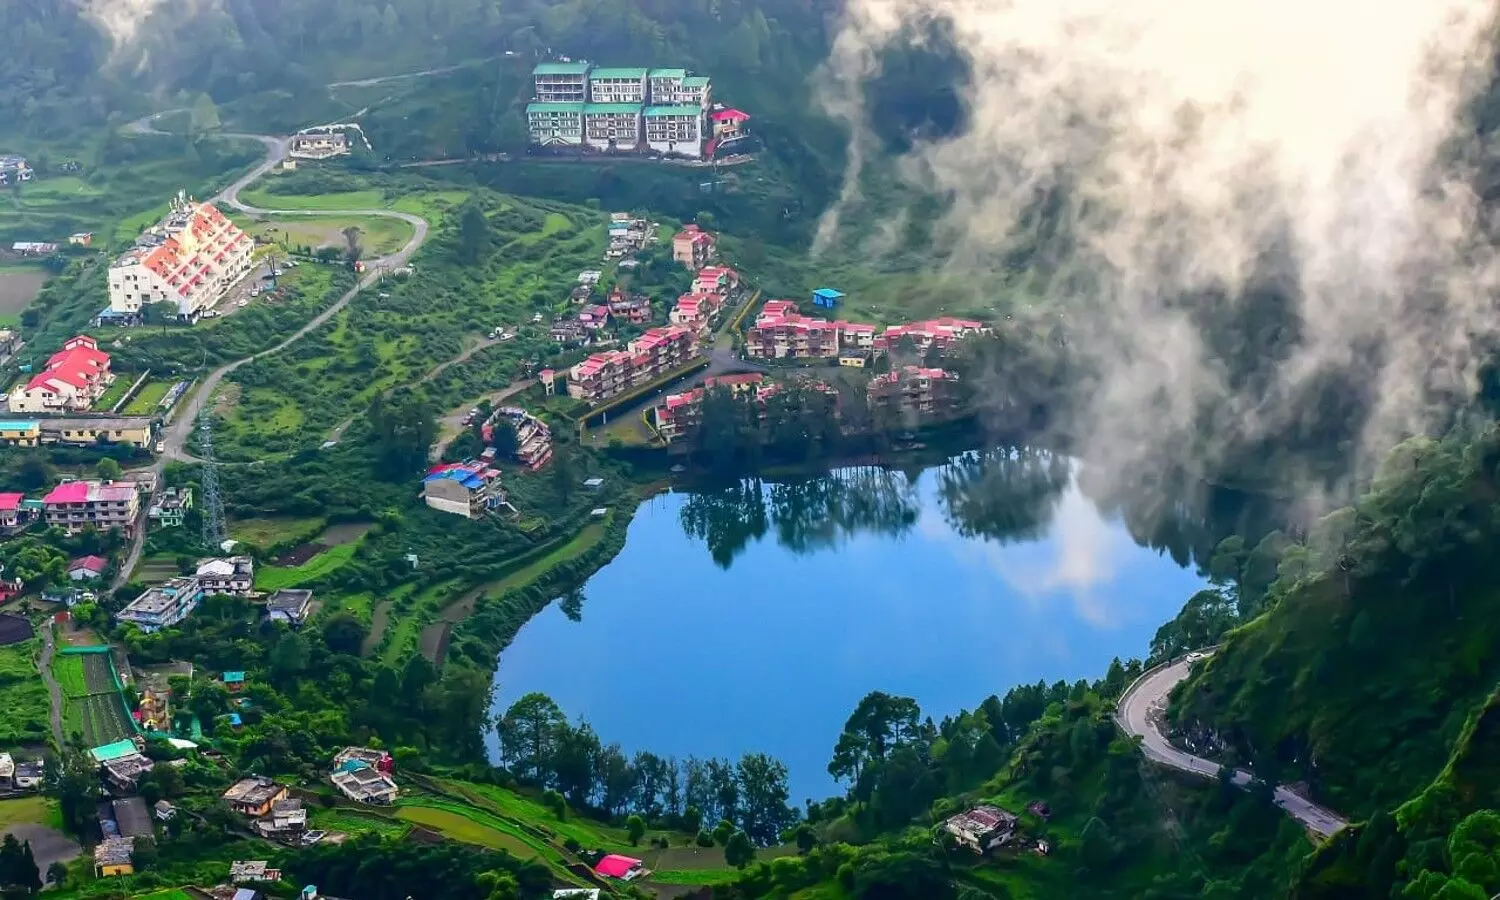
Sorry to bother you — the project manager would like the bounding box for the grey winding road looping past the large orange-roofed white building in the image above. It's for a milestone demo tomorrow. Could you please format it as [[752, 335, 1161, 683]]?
[[111, 111, 429, 590]]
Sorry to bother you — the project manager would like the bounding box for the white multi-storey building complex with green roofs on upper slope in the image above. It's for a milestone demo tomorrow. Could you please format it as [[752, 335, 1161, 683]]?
[[527, 60, 750, 159]]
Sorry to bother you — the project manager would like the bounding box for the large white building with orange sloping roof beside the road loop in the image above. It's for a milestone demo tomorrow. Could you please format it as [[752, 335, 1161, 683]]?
[[110, 195, 255, 321]]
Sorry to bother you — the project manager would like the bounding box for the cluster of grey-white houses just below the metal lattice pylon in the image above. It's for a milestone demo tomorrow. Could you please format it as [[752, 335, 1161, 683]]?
[[116, 557, 312, 635]]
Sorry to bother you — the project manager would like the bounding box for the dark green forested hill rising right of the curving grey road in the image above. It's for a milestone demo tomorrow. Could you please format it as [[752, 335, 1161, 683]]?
[[1172, 425, 1500, 897]]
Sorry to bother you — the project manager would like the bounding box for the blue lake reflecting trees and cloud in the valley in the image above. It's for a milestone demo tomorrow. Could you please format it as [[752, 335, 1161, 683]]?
[[489, 450, 1205, 804]]
